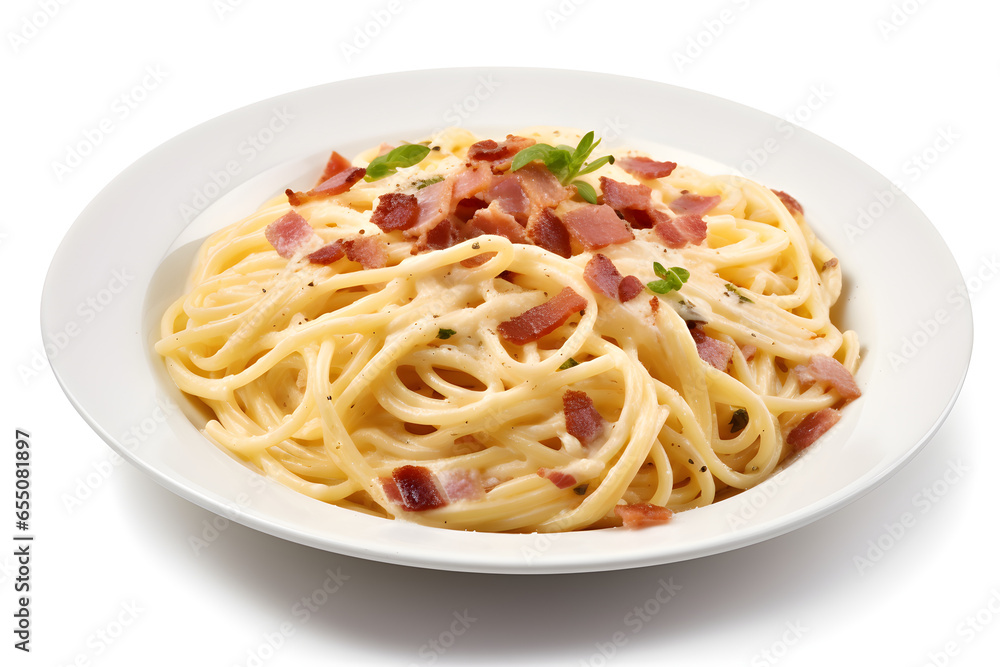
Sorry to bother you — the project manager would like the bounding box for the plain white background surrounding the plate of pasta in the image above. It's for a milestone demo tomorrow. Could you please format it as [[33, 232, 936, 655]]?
[[0, 0, 1000, 667]]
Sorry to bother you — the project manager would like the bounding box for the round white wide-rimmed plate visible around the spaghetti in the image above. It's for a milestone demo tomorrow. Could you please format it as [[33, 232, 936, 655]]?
[[42, 69, 972, 573]]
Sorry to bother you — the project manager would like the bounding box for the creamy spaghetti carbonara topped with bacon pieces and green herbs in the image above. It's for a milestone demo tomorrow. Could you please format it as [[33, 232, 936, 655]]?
[[156, 128, 860, 532]]
